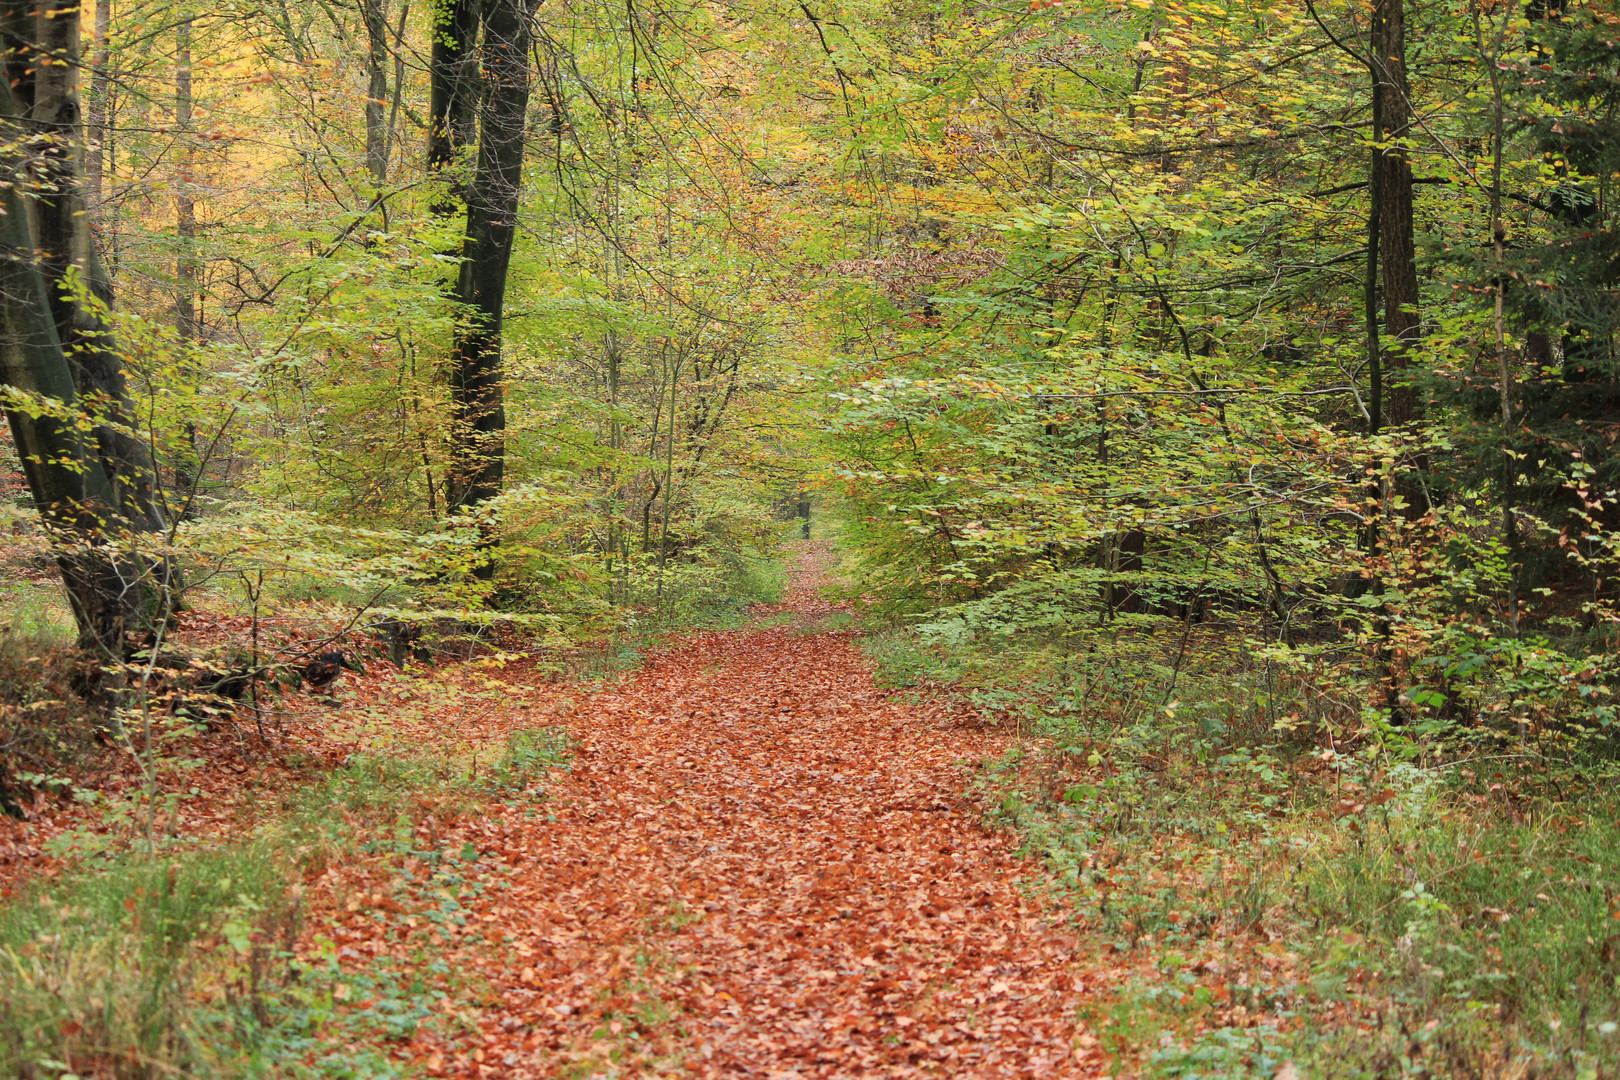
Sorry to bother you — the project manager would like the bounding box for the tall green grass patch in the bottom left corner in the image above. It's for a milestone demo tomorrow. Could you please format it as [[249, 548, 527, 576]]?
[[0, 844, 426, 1080]]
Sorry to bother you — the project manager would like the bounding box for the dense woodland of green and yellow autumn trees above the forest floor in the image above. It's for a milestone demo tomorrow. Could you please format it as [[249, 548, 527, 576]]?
[[6, 3, 1615, 705]]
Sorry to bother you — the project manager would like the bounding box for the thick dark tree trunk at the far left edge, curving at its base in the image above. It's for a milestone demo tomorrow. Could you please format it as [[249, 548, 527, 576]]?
[[0, 0, 170, 659]]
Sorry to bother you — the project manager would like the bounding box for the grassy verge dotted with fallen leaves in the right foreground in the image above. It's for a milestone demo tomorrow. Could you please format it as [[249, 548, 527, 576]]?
[[983, 731, 1620, 1080]]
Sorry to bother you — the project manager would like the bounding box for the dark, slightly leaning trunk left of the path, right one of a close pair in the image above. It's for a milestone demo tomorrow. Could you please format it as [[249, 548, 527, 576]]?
[[449, 0, 536, 527]]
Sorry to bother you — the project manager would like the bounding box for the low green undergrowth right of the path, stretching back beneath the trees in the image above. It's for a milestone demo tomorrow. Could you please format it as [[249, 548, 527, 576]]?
[[867, 621, 1620, 1080]]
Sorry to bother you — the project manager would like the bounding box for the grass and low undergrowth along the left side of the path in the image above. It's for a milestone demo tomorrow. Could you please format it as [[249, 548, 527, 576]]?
[[0, 729, 569, 1080]]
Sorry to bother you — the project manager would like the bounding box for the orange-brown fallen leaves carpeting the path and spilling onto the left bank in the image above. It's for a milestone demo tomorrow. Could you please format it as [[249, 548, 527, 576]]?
[[0, 547, 1110, 1078]]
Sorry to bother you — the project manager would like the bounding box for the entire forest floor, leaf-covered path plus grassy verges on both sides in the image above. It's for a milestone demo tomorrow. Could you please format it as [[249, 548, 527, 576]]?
[[9, 544, 1620, 1080]]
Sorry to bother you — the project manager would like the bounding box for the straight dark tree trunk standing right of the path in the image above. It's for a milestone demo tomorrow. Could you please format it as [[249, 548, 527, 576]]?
[[1369, 0, 1422, 427]]
